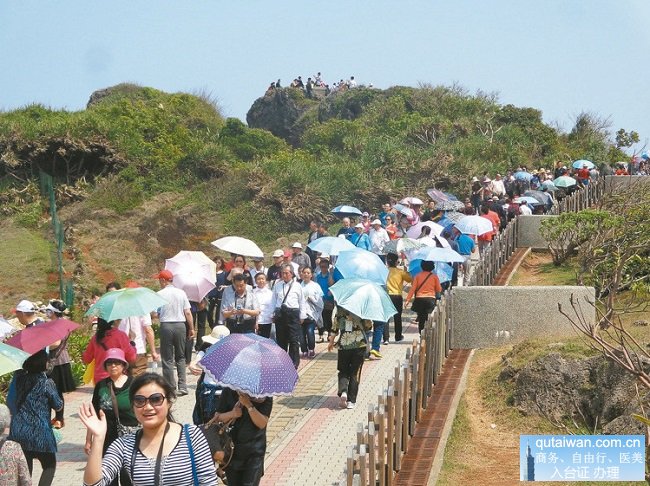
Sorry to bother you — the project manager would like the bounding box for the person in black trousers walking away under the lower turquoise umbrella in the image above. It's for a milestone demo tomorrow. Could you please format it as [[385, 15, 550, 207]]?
[[327, 307, 372, 409]]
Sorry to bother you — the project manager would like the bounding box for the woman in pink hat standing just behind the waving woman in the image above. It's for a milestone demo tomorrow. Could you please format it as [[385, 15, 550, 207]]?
[[84, 348, 139, 486]]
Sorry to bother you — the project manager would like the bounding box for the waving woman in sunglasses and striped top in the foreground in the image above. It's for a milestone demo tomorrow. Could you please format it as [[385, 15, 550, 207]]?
[[79, 373, 217, 486]]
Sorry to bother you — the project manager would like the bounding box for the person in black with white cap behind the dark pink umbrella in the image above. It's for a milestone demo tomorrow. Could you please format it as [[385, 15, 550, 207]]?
[[45, 299, 77, 429]]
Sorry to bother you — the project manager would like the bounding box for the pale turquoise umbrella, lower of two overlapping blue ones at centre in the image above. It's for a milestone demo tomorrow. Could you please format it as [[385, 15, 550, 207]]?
[[330, 278, 397, 322]]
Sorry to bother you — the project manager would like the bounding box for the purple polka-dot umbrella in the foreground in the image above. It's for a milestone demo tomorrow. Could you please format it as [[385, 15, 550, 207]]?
[[198, 333, 298, 398]]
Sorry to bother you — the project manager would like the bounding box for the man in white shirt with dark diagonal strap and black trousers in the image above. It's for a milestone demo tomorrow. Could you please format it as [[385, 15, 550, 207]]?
[[271, 264, 307, 369]]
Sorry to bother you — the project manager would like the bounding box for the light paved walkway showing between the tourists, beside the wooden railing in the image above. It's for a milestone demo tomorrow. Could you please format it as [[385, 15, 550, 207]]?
[[34, 313, 418, 486]]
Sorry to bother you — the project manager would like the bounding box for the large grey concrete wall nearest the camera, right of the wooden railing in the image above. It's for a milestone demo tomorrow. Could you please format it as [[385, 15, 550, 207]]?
[[452, 286, 596, 348]]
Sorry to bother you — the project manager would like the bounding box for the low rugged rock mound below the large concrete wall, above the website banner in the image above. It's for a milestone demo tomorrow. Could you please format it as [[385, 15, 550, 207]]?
[[499, 352, 650, 434]]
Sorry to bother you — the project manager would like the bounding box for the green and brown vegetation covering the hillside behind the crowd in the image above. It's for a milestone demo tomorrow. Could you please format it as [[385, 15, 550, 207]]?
[[0, 80, 613, 305]]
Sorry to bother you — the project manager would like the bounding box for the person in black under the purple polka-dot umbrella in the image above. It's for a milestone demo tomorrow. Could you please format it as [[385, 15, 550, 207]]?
[[214, 388, 273, 486]]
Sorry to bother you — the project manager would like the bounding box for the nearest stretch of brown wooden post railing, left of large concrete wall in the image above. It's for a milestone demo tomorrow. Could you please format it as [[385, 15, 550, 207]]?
[[342, 293, 446, 486]]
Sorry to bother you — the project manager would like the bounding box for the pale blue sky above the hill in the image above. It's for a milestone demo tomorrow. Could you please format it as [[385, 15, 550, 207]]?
[[0, 0, 650, 148]]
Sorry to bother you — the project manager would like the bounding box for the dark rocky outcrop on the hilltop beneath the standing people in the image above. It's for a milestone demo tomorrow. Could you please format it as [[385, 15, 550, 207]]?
[[246, 88, 319, 146]]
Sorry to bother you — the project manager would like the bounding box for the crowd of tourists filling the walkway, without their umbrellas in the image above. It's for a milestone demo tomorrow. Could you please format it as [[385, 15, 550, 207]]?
[[0, 159, 624, 486]]
